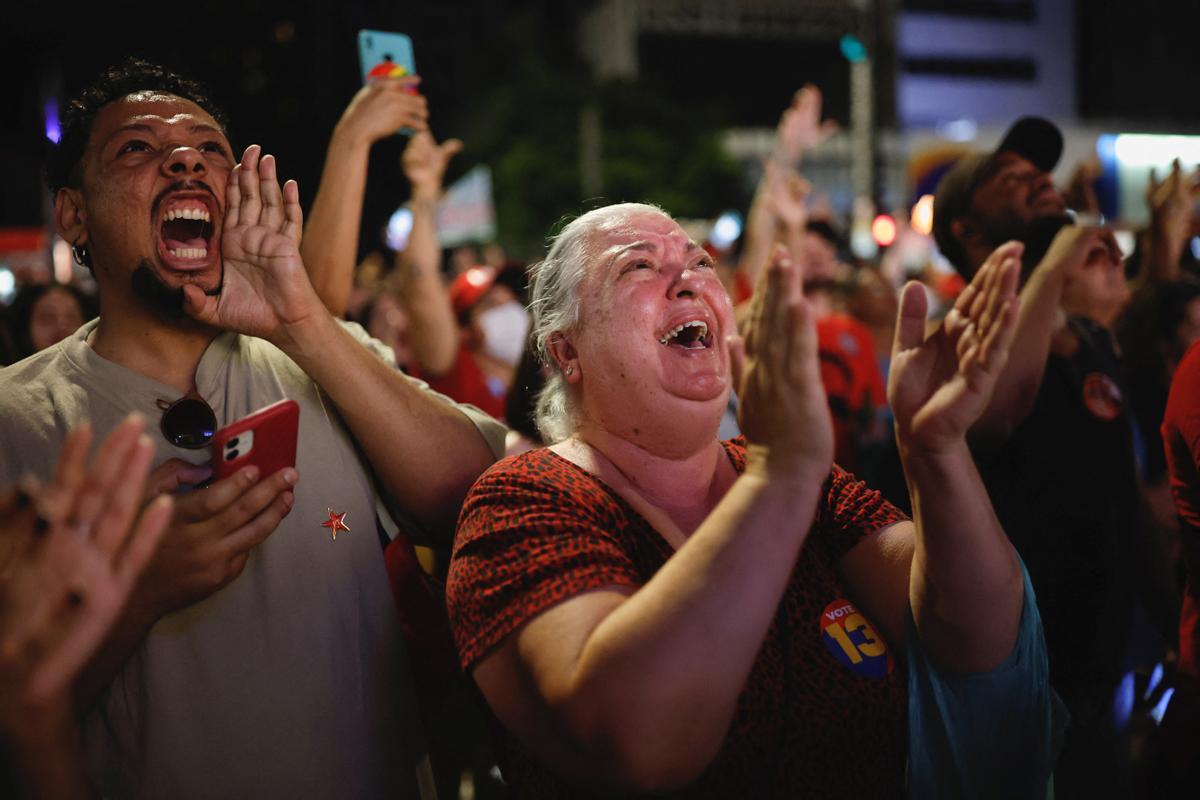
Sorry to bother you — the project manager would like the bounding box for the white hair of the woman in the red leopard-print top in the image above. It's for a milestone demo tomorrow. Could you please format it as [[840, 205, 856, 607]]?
[[529, 203, 671, 444]]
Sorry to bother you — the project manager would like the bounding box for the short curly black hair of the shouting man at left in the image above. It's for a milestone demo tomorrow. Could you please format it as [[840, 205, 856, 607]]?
[[46, 58, 227, 192]]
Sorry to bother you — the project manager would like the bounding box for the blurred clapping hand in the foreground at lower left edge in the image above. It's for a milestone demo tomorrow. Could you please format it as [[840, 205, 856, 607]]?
[[0, 415, 173, 796]]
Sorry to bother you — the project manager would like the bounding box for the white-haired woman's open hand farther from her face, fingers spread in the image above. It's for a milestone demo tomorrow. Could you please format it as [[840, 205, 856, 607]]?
[[888, 245, 1020, 453]]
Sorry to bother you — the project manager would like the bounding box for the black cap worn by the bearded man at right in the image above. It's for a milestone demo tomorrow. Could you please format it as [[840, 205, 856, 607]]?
[[934, 116, 1062, 271]]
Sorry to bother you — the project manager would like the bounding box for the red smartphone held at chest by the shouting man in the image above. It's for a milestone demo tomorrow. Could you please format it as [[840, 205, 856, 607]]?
[[212, 399, 300, 481]]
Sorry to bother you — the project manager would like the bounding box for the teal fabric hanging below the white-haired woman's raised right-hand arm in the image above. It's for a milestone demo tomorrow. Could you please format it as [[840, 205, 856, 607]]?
[[907, 564, 1068, 800]]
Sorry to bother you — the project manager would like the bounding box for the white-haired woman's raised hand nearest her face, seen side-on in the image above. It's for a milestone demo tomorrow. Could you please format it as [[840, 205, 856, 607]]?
[[730, 246, 833, 481]]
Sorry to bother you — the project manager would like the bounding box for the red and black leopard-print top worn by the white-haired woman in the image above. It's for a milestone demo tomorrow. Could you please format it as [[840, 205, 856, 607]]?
[[446, 439, 907, 800]]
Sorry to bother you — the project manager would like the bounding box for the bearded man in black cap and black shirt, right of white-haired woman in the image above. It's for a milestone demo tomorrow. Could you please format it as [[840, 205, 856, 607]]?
[[934, 118, 1176, 798]]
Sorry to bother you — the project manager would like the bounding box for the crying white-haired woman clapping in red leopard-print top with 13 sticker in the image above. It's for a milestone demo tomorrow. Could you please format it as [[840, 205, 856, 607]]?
[[448, 204, 1052, 798]]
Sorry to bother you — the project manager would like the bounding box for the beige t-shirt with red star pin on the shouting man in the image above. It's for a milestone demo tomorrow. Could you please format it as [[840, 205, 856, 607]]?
[[0, 323, 504, 798]]
